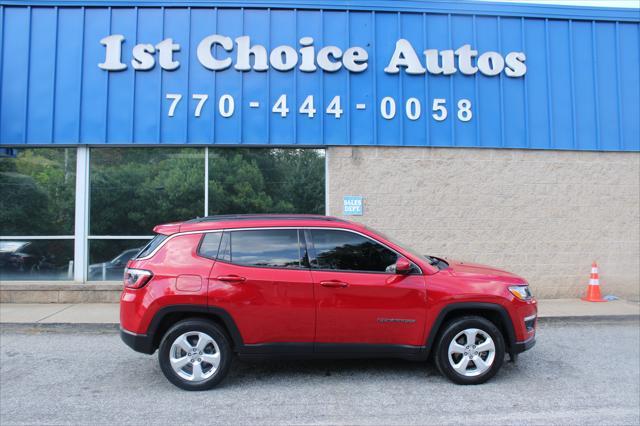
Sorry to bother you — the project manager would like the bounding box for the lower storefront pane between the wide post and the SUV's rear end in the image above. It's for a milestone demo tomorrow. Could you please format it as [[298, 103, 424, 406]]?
[[87, 240, 149, 281]]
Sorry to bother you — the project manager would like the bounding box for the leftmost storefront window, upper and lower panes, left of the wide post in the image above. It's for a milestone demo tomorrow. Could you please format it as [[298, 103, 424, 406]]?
[[0, 148, 76, 281]]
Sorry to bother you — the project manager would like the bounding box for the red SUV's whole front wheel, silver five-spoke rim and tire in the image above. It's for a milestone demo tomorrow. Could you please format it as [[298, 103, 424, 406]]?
[[435, 316, 505, 385]]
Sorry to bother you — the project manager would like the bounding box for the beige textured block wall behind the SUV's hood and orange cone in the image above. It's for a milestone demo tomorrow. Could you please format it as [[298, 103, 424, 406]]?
[[328, 147, 640, 300]]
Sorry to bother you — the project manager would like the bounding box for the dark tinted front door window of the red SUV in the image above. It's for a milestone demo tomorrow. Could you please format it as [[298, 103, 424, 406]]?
[[311, 229, 398, 273]]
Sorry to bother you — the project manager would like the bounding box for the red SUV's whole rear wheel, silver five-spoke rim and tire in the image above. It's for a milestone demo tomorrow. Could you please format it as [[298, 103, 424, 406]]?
[[158, 319, 232, 390]]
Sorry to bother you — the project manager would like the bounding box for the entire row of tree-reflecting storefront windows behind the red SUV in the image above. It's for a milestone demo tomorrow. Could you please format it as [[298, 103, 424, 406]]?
[[0, 147, 325, 281]]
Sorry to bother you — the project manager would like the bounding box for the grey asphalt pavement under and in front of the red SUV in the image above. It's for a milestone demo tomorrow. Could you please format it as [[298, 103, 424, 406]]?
[[0, 319, 640, 425]]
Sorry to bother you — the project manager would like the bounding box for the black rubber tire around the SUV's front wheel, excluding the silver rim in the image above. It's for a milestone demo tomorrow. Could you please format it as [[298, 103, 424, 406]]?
[[434, 316, 505, 385]]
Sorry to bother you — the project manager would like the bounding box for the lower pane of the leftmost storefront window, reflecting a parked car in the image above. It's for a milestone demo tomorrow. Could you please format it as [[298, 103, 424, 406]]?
[[0, 239, 73, 281]]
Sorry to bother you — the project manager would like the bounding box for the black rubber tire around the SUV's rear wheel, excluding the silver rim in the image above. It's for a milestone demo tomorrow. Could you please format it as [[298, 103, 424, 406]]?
[[158, 318, 233, 391]]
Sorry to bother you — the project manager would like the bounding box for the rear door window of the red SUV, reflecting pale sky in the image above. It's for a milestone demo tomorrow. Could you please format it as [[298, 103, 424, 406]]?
[[226, 229, 302, 268]]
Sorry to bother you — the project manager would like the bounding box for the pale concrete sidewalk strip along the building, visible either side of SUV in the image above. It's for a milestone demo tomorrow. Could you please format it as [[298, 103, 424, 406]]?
[[0, 299, 640, 325]]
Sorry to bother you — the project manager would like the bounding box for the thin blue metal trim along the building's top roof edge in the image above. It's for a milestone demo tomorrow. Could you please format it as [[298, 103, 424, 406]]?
[[0, 0, 640, 22]]
